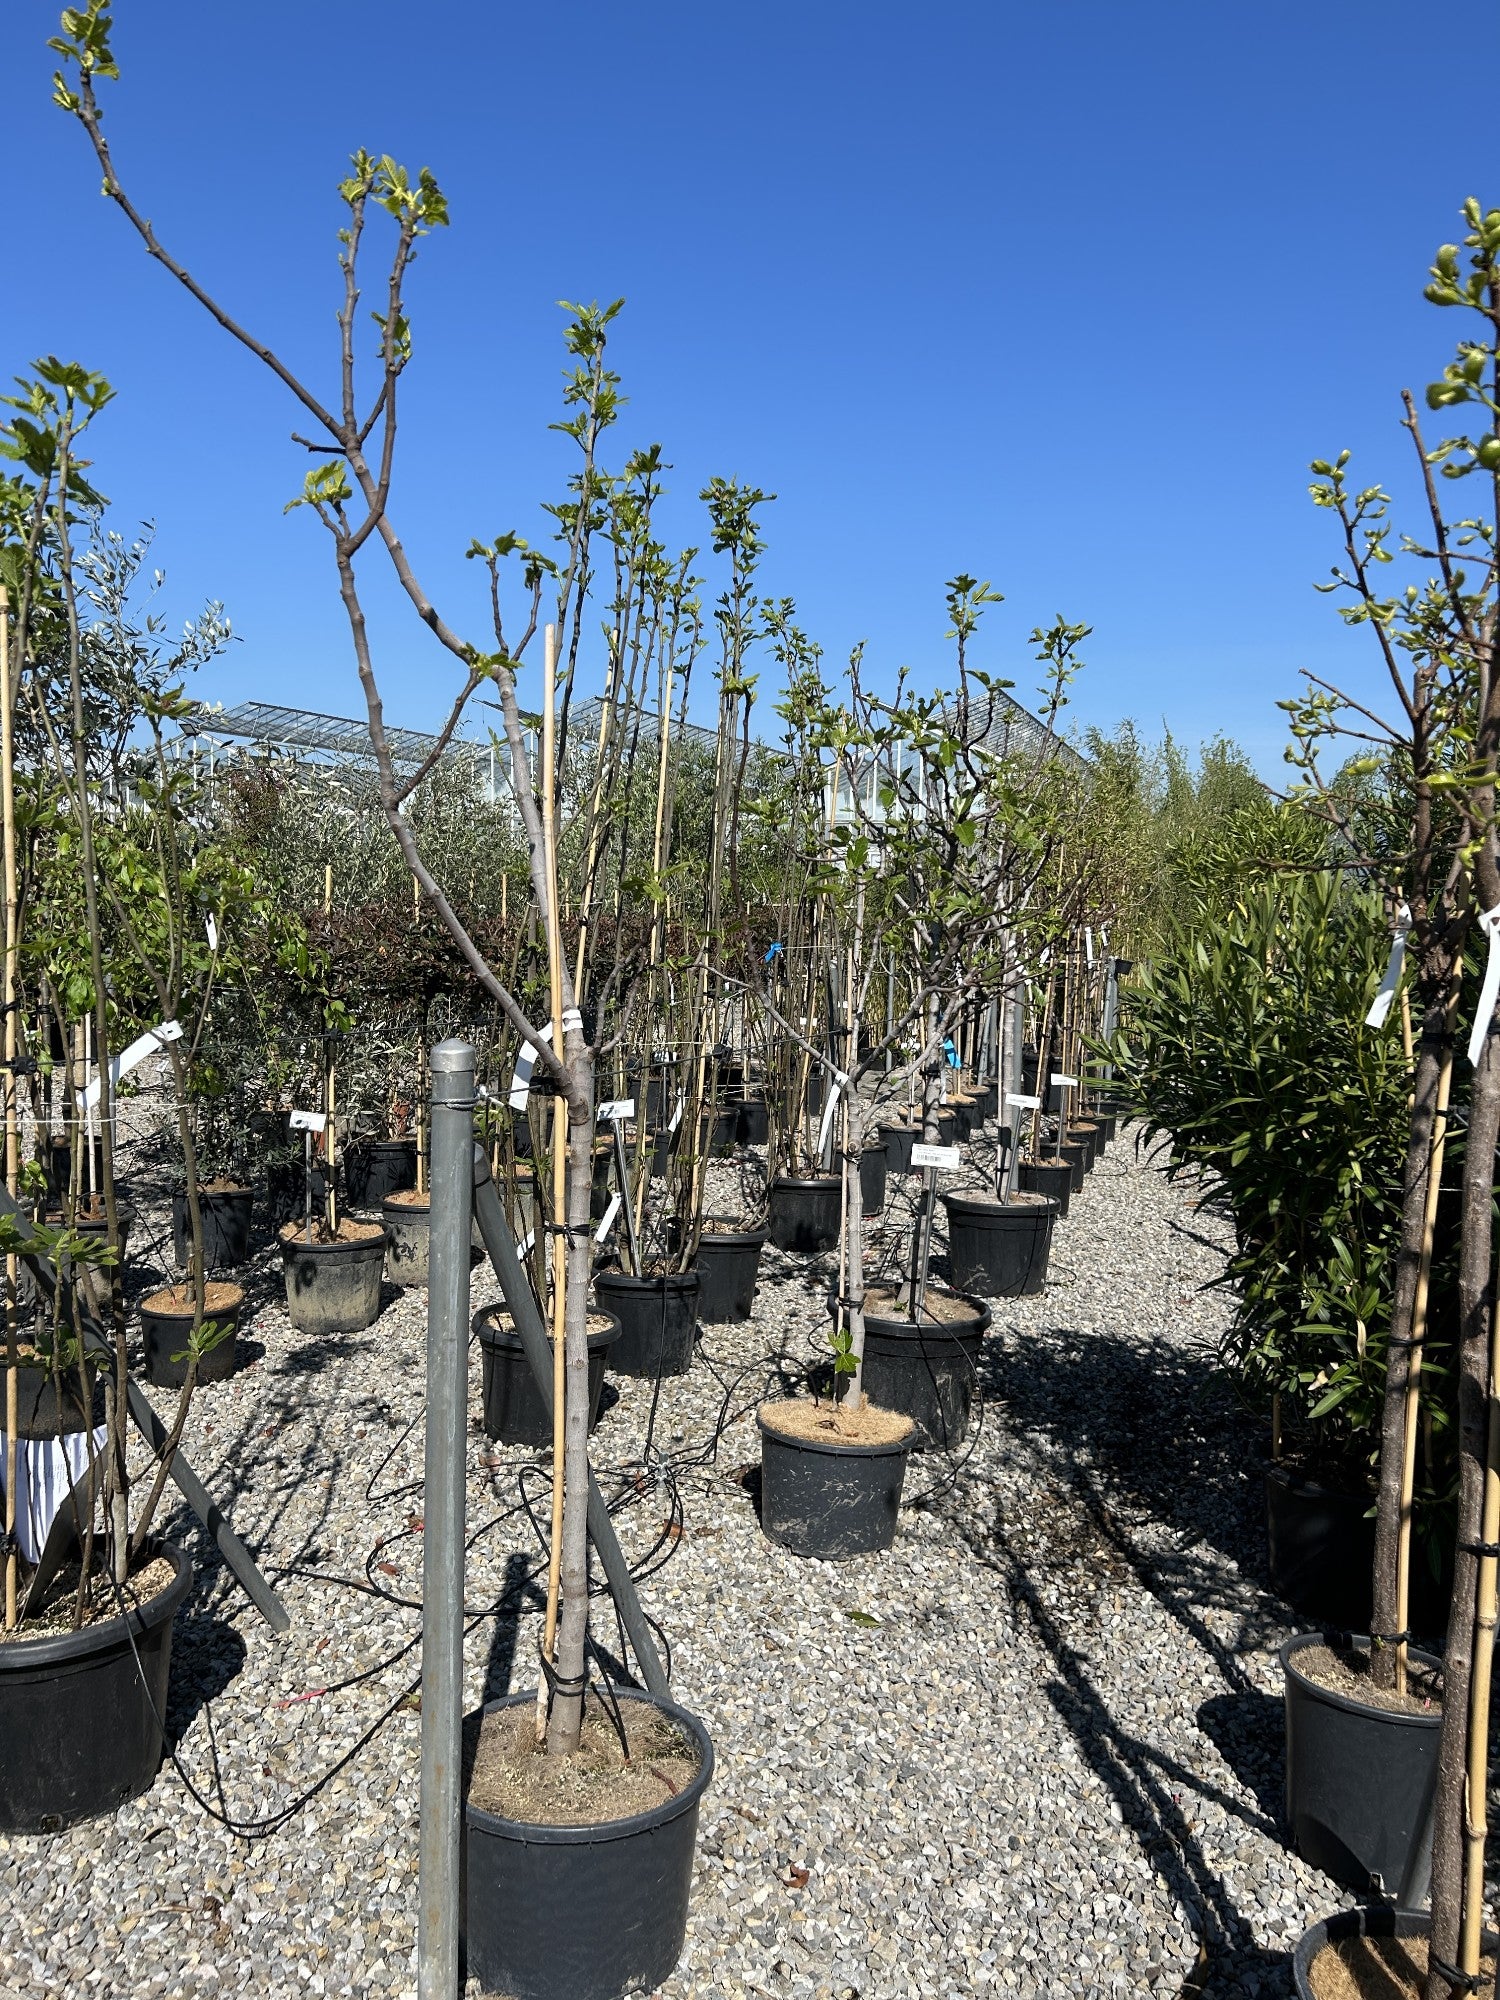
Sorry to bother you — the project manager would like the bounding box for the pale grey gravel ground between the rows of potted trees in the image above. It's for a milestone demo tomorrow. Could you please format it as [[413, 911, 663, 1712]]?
[[0, 1136, 1376, 2000]]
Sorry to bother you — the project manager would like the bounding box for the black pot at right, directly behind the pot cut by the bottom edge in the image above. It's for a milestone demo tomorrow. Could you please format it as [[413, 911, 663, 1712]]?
[[1280, 1632, 1442, 1896]]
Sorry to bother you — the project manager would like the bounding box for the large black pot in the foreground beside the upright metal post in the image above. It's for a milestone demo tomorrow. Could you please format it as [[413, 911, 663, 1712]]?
[[462, 1688, 714, 2000]]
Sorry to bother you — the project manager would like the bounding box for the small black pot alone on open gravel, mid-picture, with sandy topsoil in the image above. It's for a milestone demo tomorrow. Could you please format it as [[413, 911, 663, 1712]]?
[[756, 1416, 912, 1562]]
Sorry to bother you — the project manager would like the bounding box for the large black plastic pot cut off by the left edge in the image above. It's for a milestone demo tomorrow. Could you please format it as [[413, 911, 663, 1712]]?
[[0, 1542, 192, 1834]]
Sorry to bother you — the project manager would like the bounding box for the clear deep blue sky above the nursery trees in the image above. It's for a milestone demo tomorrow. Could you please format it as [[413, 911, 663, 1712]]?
[[0, 0, 1500, 774]]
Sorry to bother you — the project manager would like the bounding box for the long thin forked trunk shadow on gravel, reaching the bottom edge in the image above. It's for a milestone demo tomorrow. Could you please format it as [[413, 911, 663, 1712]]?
[[964, 1510, 1288, 2000]]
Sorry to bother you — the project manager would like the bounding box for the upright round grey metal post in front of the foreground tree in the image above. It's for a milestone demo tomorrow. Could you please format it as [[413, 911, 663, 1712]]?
[[416, 1040, 474, 2000]]
